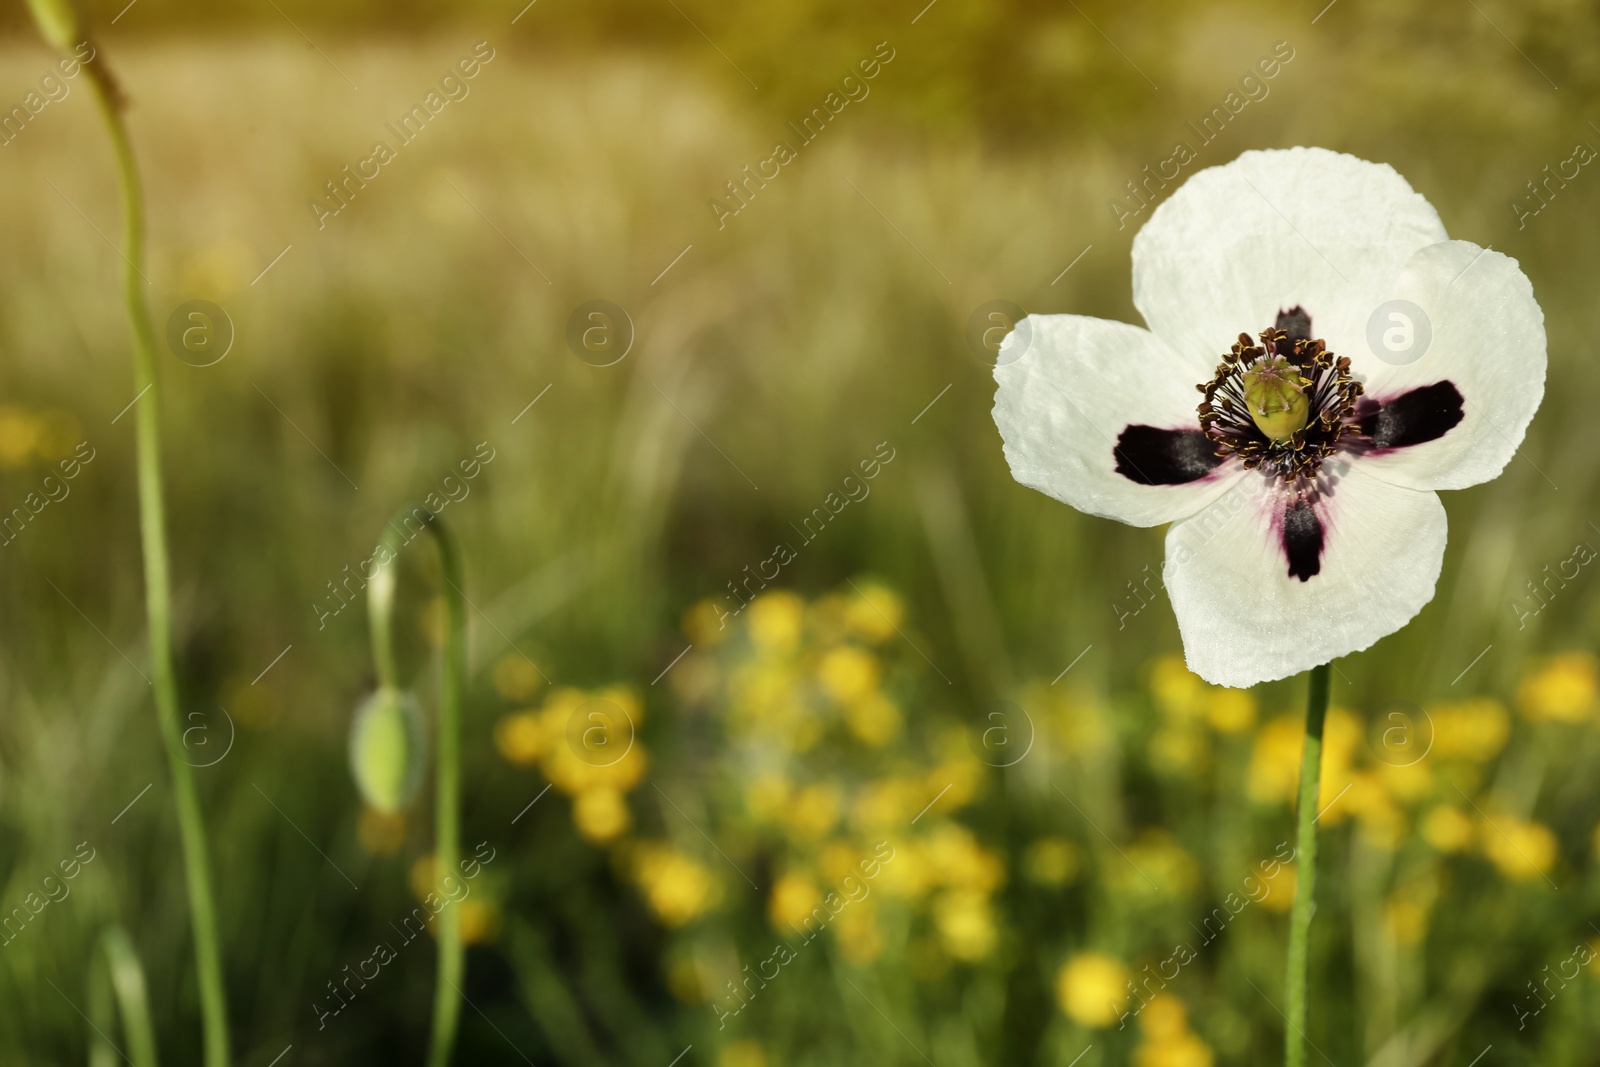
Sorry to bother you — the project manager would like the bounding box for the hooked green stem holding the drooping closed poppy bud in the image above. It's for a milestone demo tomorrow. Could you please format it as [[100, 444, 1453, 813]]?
[[366, 507, 467, 1067]]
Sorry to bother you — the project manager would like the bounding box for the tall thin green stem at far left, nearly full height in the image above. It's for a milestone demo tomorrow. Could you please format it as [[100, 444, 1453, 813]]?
[[85, 58, 227, 1067]]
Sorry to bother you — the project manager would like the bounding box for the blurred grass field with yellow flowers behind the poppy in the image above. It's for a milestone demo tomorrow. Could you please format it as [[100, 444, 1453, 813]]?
[[0, 0, 1600, 1067]]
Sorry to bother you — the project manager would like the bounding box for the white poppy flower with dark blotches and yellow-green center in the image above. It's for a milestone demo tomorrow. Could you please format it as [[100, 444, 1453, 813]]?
[[994, 149, 1546, 686]]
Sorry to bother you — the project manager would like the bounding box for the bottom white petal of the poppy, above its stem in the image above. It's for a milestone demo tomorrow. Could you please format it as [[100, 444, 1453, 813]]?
[[1163, 461, 1445, 688]]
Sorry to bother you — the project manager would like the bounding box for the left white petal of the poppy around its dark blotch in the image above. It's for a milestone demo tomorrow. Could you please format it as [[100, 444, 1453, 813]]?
[[994, 315, 1242, 526]]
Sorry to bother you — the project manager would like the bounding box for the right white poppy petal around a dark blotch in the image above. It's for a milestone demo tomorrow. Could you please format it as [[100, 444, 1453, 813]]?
[[1339, 242, 1546, 490]]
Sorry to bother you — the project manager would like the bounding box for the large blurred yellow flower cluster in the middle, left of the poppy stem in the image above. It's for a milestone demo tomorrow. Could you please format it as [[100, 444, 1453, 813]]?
[[675, 579, 1004, 977]]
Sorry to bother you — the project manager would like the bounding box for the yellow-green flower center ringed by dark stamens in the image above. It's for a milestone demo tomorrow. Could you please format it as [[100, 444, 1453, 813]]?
[[1195, 307, 1362, 478]]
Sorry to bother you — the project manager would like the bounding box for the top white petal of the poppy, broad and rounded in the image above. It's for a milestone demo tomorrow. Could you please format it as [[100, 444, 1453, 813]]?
[[1133, 149, 1446, 363]]
